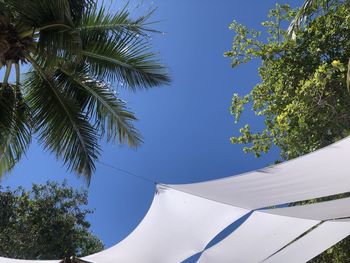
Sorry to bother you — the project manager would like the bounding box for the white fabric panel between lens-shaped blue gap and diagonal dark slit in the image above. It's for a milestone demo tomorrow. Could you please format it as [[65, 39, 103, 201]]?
[[198, 212, 319, 263]]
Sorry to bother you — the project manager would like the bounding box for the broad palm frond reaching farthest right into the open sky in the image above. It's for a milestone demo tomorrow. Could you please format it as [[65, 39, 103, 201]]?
[[81, 34, 170, 90]]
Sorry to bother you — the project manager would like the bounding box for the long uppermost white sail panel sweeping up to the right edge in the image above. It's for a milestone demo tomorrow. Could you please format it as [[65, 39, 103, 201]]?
[[171, 137, 350, 209]]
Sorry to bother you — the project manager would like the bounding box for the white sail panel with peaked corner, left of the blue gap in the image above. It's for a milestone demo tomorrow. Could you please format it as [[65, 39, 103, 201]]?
[[83, 187, 249, 263]]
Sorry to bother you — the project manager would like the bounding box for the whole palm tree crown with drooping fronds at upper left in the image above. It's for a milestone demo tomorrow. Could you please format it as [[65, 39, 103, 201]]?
[[0, 0, 169, 184]]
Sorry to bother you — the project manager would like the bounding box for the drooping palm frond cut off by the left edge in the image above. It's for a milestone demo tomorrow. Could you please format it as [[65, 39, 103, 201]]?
[[0, 85, 31, 177]]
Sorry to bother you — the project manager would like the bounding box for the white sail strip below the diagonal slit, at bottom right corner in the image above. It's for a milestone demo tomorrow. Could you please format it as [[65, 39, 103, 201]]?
[[264, 221, 350, 263]]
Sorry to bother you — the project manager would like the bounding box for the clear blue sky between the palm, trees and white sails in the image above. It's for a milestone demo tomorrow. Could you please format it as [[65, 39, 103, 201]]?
[[0, 0, 302, 260]]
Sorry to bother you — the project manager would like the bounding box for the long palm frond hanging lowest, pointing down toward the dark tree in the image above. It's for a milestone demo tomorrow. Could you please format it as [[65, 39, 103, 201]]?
[[25, 58, 99, 182]]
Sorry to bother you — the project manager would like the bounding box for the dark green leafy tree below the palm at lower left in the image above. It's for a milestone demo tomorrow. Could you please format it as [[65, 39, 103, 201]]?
[[0, 182, 103, 260]]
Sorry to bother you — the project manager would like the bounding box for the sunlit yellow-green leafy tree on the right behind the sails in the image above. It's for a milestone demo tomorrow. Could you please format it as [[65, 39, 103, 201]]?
[[225, 0, 350, 262]]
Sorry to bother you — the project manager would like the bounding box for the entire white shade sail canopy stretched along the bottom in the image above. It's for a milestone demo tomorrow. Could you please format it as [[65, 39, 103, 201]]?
[[0, 137, 350, 263]]
